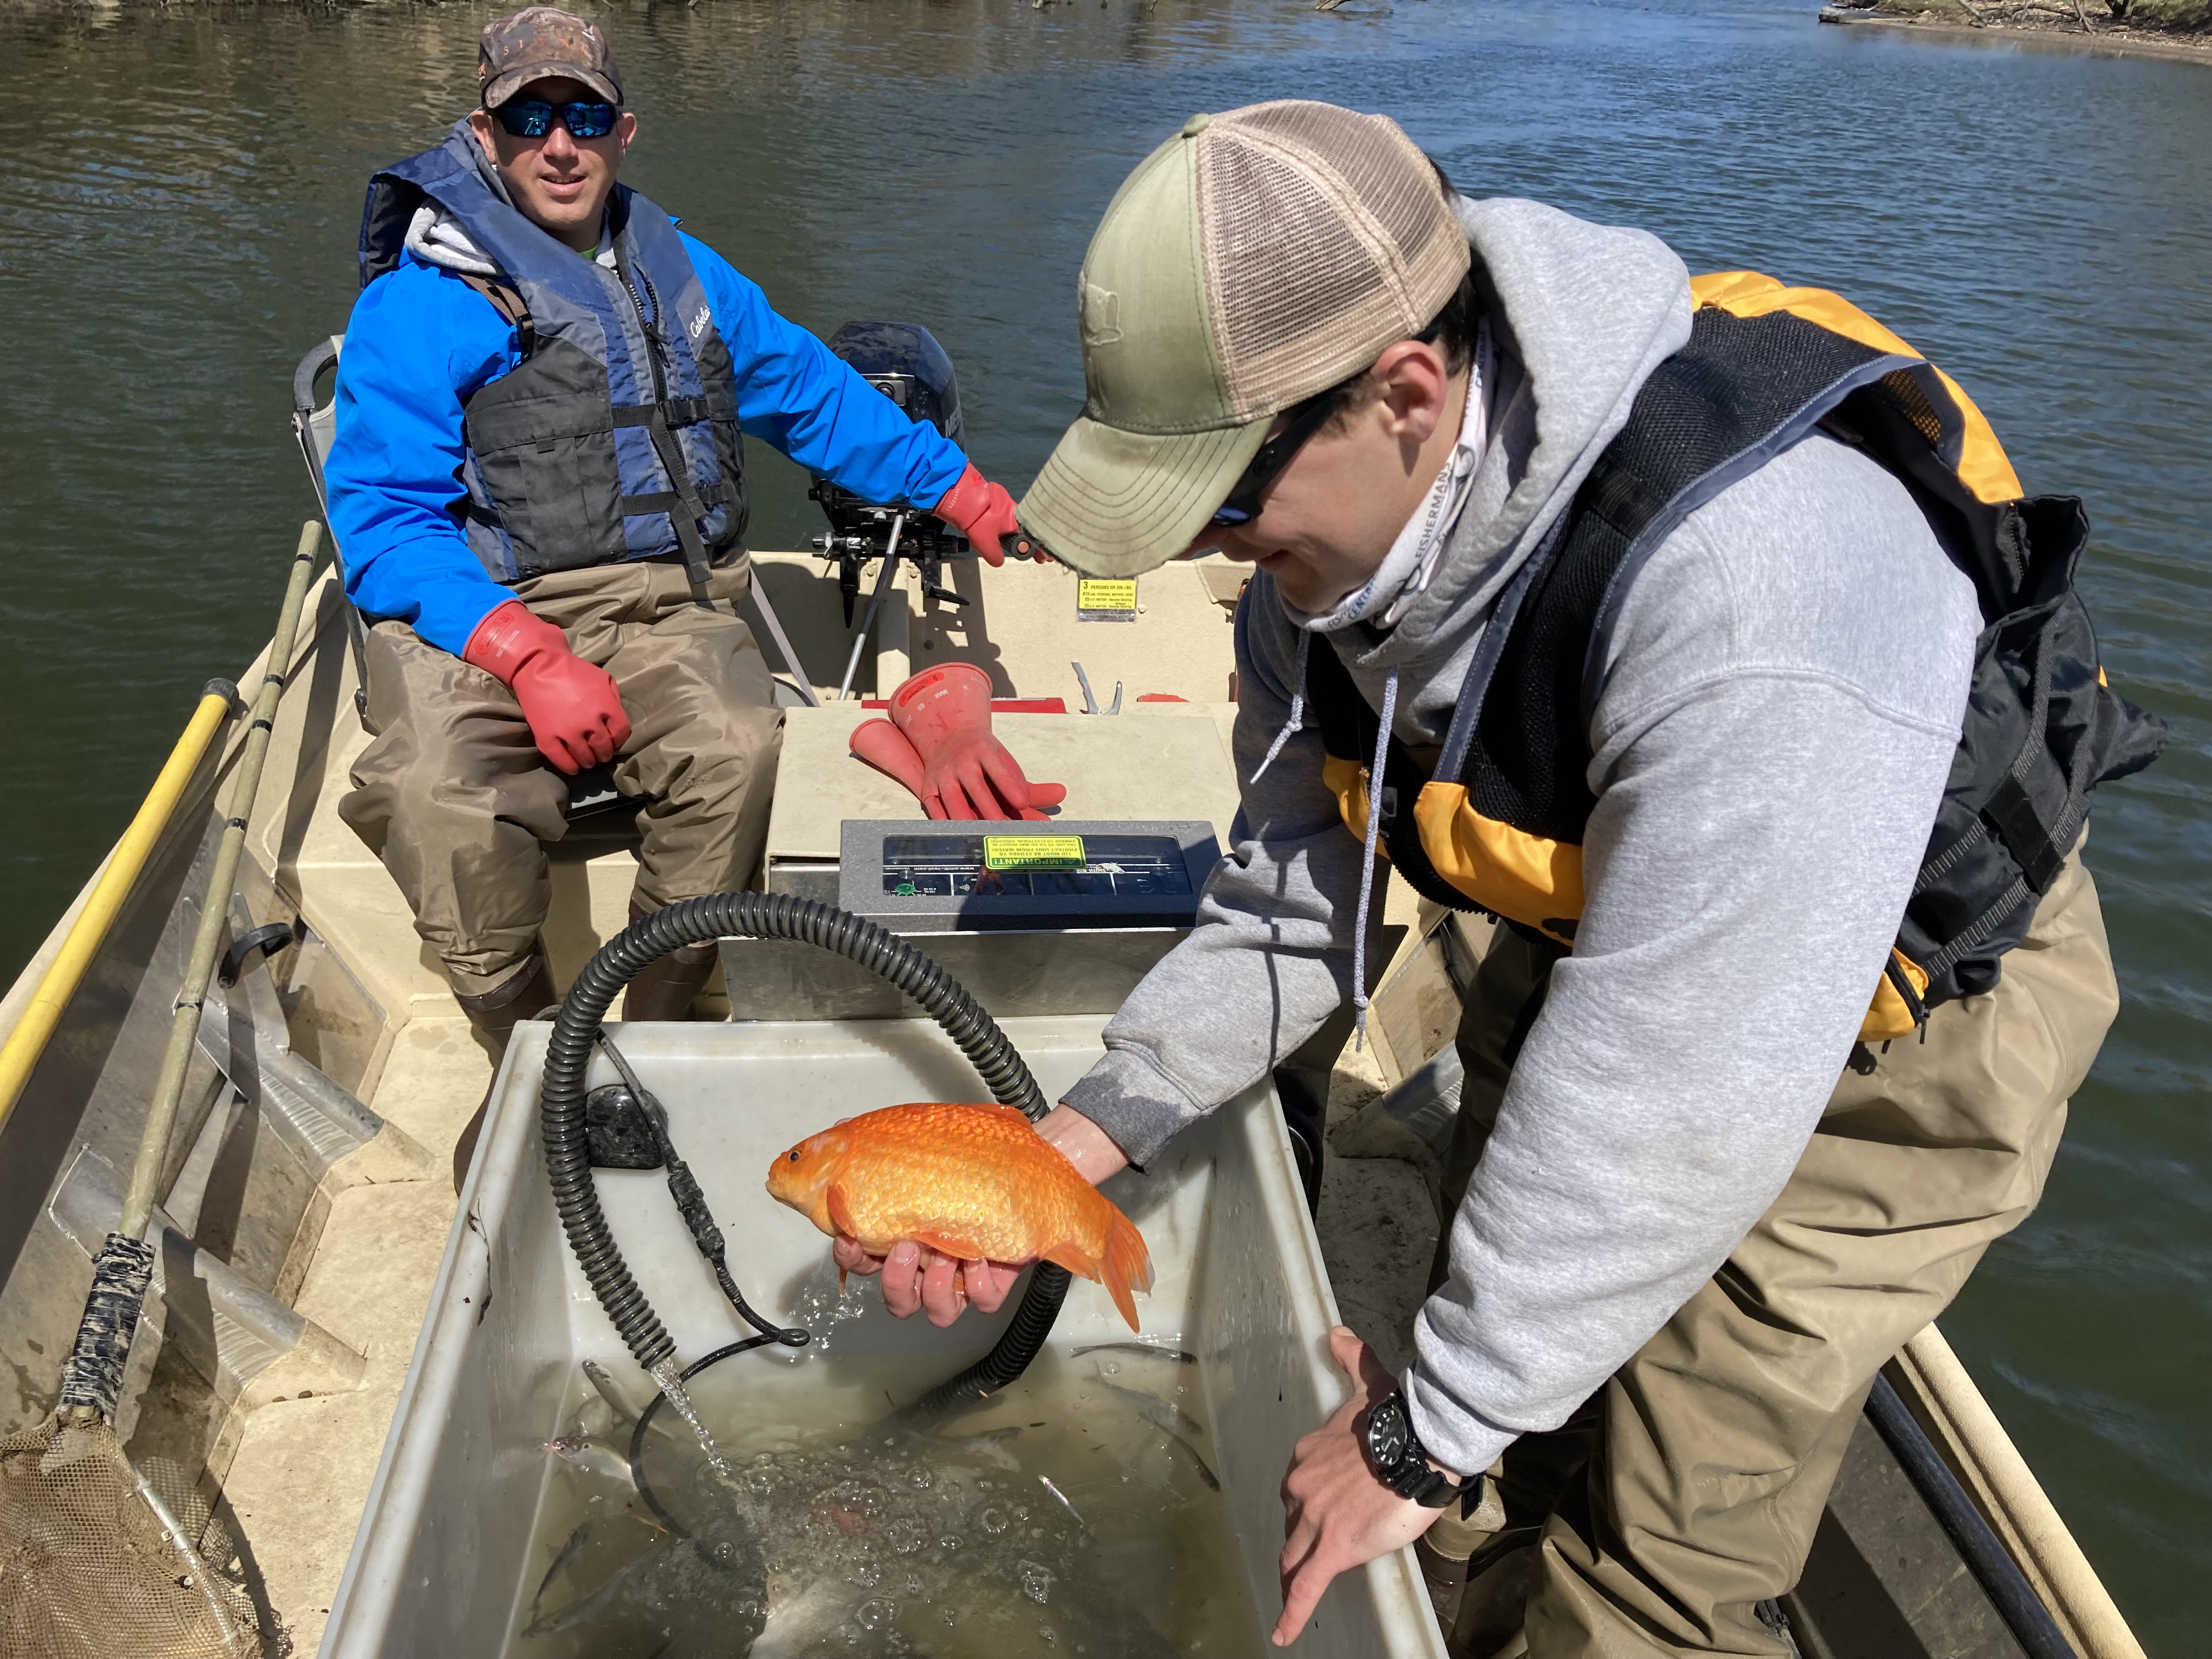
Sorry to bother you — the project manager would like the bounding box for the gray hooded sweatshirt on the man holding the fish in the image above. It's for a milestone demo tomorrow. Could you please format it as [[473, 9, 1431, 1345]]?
[[1066, 199, 1980, 1471]]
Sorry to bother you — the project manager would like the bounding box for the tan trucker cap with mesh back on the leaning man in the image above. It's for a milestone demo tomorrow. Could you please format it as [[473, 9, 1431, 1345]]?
[[1020, 99, 1469, 575]]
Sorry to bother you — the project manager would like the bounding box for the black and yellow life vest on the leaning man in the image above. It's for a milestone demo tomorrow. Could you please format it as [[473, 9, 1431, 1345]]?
[[1305, 272, 2165, 1042]]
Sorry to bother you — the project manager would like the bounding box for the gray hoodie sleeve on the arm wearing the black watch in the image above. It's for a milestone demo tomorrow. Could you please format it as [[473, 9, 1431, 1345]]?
[[1404, 440, 1980, 1471]]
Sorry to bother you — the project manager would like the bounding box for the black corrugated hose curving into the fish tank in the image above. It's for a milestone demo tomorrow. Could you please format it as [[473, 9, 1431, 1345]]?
[[540, 894, 1068, 1420]]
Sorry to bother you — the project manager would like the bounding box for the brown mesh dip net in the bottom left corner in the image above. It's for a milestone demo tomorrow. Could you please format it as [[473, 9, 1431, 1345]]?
[[0, 1411, 263, 1659]]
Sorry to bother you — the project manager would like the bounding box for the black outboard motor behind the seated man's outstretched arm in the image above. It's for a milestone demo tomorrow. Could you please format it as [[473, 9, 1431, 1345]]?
[[808, 323, 973, 628]]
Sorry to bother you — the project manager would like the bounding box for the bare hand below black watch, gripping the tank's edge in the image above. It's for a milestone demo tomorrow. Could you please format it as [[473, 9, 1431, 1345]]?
[[1274, 1325, 1442, 1648]]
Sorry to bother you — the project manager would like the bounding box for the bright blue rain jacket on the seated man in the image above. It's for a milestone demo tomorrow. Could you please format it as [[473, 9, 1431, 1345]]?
[[323, 232, 967, 657]]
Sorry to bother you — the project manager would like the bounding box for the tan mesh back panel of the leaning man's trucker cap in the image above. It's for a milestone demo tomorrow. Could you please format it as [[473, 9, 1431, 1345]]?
[[1194, 101, 1466, 420]]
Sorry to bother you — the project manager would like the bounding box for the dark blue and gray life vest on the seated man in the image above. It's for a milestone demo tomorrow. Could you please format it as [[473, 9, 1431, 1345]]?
[[360, 122, 746, 584]]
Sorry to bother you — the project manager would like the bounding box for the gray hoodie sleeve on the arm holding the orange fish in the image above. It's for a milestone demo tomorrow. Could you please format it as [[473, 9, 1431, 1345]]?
[[1064, 575, 1383, 1166]]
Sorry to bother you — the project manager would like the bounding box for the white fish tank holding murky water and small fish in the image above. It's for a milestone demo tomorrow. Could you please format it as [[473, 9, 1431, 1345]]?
[[323, 1015, 1442, 1659]]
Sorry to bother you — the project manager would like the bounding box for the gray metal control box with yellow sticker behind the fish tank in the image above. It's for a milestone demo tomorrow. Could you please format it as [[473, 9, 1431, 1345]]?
[[721, 819, 1221, 1020]]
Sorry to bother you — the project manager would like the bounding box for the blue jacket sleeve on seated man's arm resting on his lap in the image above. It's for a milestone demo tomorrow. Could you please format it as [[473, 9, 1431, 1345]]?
[[323, 263, 520, 657]]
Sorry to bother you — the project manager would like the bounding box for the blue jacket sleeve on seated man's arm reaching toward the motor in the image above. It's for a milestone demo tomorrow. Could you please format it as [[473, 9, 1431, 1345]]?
[[679, 232, 967, 509]]
